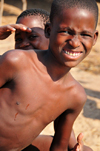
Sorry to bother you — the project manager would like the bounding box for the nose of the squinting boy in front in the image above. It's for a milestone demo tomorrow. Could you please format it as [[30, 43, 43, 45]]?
[[69, 36, 80, 48]]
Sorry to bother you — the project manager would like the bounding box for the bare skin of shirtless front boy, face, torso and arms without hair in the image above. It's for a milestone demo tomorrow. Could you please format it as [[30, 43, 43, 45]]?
[[0, 8, 98, 151]]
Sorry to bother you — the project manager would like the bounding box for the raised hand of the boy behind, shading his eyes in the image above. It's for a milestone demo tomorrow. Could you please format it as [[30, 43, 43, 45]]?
[[0, 24, 32, 40]]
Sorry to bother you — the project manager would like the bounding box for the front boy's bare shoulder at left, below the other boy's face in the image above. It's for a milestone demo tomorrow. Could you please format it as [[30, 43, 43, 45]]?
[[0, 50, 34, 87]]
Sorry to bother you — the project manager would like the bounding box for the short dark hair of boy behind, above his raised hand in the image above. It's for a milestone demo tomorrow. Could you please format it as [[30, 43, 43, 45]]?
[[16, 8, 50, 26]]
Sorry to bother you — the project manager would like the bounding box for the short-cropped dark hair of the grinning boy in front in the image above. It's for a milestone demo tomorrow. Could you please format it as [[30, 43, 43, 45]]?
[[50, 0, 98, 25]]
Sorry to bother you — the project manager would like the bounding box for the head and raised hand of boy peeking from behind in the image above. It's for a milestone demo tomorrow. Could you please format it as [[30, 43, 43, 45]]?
[[0, 8, 50, 50]]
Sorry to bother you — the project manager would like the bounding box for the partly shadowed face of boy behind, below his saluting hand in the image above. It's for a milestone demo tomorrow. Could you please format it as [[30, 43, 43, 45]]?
[[15, 15, 49, 50]]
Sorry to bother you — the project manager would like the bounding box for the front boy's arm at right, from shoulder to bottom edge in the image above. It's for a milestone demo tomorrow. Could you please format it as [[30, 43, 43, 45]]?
[[50, 85, 87, 151]]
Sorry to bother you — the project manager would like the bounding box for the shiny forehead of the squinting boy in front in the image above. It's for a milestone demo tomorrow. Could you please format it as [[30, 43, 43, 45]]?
[[54, 7, 96, 28]]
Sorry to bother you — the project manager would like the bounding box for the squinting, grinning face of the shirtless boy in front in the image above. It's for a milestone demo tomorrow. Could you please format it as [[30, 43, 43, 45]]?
[[48, 7, 98, 68]]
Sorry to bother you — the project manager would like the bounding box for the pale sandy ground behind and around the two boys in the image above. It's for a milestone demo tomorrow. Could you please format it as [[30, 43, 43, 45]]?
[[0, 1, 100, 151]]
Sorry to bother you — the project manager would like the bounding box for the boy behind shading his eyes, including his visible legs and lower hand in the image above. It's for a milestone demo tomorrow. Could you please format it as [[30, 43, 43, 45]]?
[[0, 8, 93, 151]]
